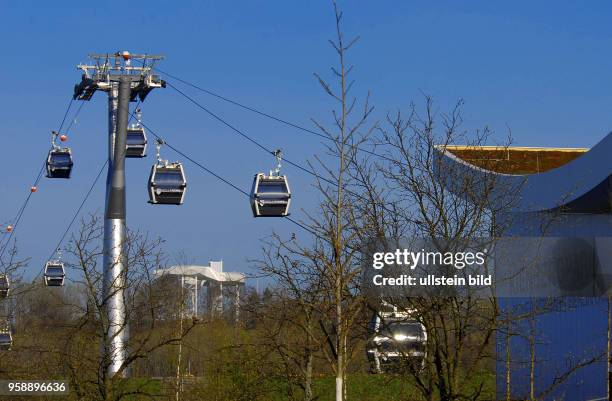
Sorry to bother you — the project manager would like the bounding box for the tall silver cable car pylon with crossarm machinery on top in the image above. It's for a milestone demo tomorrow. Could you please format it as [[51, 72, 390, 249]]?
[[73, 51, 165, 377]]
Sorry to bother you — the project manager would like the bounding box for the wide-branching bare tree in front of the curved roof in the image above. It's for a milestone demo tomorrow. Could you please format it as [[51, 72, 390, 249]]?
[[352, 96, 506, 401]]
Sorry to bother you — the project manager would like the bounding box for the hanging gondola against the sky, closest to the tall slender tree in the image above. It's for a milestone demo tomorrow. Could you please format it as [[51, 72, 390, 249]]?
[[250, 150, 291, 217]]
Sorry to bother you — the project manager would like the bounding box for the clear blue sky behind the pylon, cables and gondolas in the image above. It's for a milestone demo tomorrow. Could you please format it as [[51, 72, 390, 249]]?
[[0, 1, 612, 278]]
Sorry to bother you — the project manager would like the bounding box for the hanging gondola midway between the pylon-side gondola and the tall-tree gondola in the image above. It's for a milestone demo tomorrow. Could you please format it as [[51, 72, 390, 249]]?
[[149, 139, 187, 205]]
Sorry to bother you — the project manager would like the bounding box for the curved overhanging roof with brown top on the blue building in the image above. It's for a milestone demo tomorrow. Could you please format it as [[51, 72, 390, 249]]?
[[434, 133, 612, 213]]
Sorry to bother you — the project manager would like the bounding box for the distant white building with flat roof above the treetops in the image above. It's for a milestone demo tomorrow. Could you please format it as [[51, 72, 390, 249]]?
[[155, 261, 246, 319]]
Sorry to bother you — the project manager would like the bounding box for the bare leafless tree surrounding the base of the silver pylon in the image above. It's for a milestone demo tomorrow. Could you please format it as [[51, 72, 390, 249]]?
[[59, 216, 197, 401]]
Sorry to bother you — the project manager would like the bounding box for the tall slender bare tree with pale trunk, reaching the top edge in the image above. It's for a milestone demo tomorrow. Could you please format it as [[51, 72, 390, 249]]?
[[308, 2, 373, 401]]
